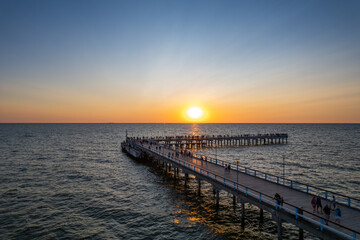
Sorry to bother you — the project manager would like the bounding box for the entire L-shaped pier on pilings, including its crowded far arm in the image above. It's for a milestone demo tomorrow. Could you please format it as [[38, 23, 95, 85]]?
[[122, 134, 360, 240]]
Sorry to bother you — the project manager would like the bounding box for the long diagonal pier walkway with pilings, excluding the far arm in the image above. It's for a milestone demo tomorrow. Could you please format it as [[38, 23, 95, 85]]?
[[122, 135, 360, 239]]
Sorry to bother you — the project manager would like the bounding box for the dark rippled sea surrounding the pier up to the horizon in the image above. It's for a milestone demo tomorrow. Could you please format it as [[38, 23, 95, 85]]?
[[0, 124, 360, 239]]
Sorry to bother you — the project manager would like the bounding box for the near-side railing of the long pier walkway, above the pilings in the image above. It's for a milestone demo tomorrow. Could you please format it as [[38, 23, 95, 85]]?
[[138, 143, 360, 240]]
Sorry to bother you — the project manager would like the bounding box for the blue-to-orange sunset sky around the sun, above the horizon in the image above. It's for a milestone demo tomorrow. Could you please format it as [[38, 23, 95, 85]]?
[[0, 0, 360, 123]]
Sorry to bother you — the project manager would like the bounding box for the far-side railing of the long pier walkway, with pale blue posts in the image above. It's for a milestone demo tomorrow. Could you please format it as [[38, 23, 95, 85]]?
[[188, 151, 360, 210]]
